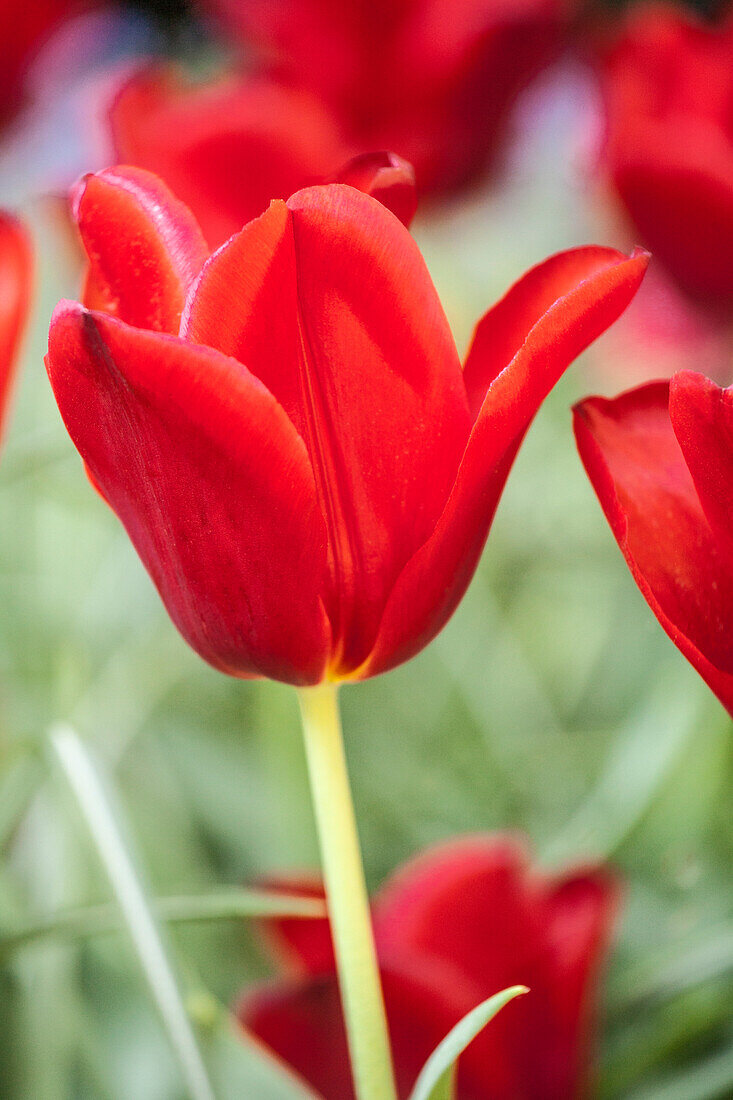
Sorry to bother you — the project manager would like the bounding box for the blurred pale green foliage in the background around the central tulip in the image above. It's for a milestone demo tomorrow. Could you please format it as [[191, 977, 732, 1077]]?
[[0, 30, 733, 1100]]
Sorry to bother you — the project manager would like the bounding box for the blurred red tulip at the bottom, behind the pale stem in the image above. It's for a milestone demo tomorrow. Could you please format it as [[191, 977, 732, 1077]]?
[[239, 836, 617, 1100]]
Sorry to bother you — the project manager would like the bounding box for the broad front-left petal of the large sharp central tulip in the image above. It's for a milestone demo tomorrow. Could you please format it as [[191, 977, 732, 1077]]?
[[47, 303, 328, 684]]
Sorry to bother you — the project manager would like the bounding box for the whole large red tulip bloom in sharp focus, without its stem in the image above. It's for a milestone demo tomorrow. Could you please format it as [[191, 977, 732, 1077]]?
[[47, 168, 647, 684]]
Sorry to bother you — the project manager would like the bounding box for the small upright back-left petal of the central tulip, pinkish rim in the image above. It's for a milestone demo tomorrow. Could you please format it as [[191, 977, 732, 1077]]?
[[73, 166, 208, 333]]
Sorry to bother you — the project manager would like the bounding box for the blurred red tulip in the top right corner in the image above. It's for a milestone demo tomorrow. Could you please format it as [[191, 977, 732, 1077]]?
[[604, 4, 733, 311]]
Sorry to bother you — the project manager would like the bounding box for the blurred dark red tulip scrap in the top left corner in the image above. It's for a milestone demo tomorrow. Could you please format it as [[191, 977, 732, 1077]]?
[[0, 0, 94, 124]]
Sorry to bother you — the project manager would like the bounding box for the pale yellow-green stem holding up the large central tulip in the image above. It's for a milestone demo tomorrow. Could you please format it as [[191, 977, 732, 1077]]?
[[298, 683, 397, 1100]]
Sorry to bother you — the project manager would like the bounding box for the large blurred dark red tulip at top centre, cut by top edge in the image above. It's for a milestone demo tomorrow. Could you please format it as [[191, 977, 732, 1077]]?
[[201, 0, 570, 194]]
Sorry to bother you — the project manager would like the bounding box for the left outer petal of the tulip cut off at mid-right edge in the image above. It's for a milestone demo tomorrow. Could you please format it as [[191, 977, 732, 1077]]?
[[575, 383, 733, 713]]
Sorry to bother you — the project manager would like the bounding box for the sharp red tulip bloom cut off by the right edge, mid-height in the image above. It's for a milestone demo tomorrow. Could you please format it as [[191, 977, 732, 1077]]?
[[575, 371, 733, 714]]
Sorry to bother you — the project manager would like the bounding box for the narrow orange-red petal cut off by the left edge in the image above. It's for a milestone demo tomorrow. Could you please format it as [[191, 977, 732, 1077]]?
[[0, 212, 33, 430]]
